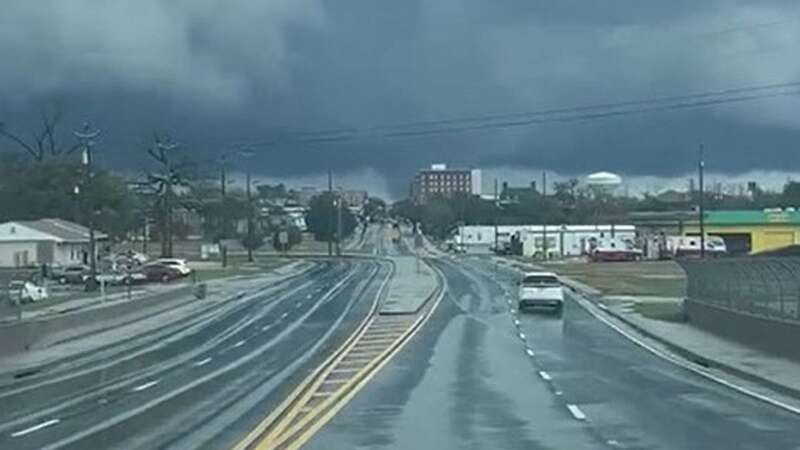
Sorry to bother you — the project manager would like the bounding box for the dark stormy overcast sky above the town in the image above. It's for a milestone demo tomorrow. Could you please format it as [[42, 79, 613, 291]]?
[[0, 0, 800, 196]]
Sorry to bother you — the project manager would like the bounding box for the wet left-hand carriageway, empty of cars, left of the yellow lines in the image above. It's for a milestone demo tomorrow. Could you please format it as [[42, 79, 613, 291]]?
[[0, 261, 390, 450]]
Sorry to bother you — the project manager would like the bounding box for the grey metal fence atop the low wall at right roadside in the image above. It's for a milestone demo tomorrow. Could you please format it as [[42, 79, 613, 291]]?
[[678, 257, 800, 324]]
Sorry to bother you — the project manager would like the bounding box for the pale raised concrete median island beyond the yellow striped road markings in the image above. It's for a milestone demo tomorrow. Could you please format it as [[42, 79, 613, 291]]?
[[379, 256, 439, 315]]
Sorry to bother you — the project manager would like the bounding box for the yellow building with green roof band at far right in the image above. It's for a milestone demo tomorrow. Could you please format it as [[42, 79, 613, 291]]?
[[683, 208, 800, 253]]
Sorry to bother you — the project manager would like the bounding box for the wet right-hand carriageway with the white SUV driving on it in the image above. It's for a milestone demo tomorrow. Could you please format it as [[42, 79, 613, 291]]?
[[304, 260, 800, 450]]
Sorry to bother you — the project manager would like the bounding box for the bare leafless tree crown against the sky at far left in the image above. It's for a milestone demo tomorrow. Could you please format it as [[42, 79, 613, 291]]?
[[0, 105, 81, 161]]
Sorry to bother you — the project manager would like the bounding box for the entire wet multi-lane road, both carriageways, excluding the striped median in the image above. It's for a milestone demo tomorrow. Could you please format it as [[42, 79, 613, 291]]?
[[0, 227, 800, 450]]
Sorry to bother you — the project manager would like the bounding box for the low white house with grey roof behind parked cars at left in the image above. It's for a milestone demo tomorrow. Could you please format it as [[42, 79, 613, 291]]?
[[0, 219, 108, 267]]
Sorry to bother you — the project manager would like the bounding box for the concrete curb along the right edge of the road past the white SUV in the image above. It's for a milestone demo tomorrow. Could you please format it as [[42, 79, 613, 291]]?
[[561, 277, 800, 399]]
